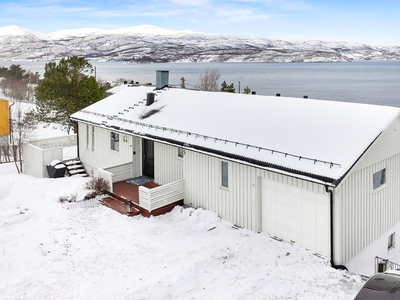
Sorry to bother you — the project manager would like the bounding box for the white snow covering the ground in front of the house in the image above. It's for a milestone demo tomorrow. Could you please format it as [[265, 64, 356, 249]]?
[[0, 164, 363, 300]]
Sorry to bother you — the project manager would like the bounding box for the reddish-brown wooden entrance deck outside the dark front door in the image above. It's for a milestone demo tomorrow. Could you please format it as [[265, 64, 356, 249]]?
[[101, 181, 183, 217]]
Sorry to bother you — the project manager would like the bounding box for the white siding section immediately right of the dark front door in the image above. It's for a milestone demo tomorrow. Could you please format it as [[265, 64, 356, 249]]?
[[154, 142, 184, 184]]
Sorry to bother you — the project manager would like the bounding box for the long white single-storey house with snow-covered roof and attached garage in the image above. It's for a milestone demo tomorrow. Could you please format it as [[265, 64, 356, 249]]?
[[71, 72, 400, 275]]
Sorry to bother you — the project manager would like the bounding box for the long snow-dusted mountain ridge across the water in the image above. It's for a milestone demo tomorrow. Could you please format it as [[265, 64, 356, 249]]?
[[0, 25, 400, 63]]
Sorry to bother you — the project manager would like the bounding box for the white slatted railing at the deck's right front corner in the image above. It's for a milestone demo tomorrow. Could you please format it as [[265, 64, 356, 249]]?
[[139, 179, 185, 212]]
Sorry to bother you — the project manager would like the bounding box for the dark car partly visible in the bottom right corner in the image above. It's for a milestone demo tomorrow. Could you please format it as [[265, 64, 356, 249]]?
[[354, 271, 400, 300]]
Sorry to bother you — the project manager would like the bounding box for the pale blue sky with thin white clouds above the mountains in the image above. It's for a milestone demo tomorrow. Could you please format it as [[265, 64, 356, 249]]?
[[0, 0, 400, 46]]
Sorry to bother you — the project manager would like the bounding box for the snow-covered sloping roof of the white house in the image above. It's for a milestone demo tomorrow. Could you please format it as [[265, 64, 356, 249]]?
[[72, 86, 400, 183]]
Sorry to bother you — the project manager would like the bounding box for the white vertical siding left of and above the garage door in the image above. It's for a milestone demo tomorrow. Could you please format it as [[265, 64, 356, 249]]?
[[183, 150, 329, 236]]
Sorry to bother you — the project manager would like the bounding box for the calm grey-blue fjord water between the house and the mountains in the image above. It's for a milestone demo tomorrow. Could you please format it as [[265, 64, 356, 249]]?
[[0, 61, 400, 106]]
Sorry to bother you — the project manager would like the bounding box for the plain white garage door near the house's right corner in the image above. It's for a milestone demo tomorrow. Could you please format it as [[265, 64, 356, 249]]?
[[262, 179, 330, 256]]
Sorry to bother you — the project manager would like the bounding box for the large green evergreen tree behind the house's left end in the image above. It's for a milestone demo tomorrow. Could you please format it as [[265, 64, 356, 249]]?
[[34, 56, 106, 133]]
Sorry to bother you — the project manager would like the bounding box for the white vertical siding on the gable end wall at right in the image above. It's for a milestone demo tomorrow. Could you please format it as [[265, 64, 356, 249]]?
[[334, 119, 400, 264]]
